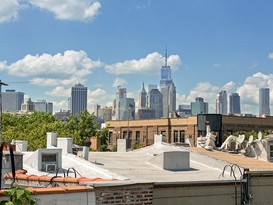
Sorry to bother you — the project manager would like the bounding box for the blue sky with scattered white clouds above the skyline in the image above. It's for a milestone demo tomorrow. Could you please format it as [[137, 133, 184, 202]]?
[[0, 0, 273, 114]]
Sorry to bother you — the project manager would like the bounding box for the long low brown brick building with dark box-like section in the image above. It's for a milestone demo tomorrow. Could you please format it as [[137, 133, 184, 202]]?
[[106, 114, 273, 148]]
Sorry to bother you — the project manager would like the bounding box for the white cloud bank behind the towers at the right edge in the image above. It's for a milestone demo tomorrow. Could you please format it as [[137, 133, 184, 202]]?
[[174, 72, 273, 115]]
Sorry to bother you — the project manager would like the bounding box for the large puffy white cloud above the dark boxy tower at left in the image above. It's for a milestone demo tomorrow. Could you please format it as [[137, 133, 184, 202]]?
[[7, 50, 102, 79]]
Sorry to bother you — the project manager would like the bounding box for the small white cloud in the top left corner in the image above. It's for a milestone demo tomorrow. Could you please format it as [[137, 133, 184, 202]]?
[[0, 0, 21, 23]]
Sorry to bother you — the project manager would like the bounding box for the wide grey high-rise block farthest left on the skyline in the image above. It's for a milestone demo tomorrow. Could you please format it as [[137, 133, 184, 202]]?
[[2, 90, 24, 112]]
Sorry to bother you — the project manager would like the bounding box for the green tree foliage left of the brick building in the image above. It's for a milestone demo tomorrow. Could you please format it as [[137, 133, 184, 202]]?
[[2, 110, 97, 151]]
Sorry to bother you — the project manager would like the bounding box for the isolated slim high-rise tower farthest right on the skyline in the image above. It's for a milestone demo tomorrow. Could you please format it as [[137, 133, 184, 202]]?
[[259, 88, 270, 117]]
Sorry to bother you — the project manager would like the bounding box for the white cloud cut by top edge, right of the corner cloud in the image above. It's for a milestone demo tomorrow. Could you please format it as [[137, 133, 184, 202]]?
[[29, 0, 101, 21]]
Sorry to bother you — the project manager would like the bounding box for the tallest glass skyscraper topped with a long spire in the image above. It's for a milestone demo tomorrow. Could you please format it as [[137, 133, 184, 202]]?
[[160, 48, 176, 117]]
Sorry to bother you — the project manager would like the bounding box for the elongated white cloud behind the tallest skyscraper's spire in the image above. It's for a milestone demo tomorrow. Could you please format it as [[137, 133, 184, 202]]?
[[105, 52, 181, 75]]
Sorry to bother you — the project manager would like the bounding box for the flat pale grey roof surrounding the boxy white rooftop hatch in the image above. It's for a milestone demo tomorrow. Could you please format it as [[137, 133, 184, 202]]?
[[84, 143, 240, 182]]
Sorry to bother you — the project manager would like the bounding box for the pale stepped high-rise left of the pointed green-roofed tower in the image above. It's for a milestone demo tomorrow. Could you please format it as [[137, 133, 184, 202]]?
[[112, 86, 135, 120]]
